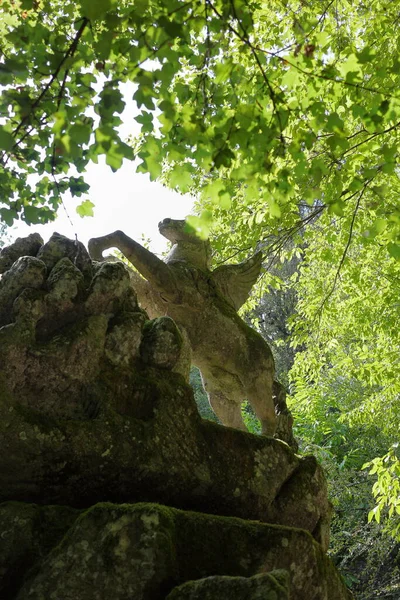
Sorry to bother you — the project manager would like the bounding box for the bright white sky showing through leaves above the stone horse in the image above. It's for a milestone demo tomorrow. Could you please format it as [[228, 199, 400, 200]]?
[[8, 84, 194, 254]]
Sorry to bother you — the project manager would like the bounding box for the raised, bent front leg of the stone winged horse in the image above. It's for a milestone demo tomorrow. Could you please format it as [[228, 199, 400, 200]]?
[[88, 230, 177, 294]]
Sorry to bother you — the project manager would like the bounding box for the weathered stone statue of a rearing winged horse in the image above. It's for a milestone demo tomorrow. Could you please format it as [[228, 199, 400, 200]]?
[[89, 219, 276, 435]]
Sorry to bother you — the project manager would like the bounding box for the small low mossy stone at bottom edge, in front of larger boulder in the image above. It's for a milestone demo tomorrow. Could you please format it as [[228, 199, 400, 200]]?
[[166, 570, 290, 600]]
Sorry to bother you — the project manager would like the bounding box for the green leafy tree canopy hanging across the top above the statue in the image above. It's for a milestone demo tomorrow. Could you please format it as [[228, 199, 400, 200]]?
[[0, 0, 400, 253]]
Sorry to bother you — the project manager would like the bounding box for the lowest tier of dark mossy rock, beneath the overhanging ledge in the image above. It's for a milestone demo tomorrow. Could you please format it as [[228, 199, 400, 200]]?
[[0, 503, 350, 600]]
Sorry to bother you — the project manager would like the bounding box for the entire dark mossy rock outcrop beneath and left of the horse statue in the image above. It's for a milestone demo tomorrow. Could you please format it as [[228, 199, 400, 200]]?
[[0, 234, 348, 600]]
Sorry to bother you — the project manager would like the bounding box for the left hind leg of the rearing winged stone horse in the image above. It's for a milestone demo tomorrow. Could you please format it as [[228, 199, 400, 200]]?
[[201, 372, 247, 431]]
